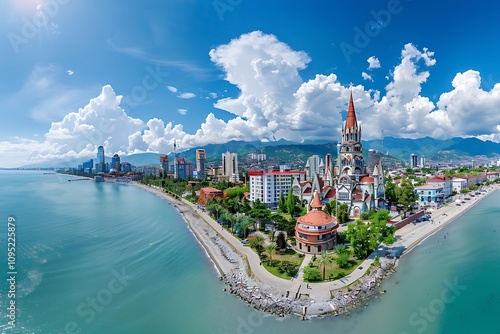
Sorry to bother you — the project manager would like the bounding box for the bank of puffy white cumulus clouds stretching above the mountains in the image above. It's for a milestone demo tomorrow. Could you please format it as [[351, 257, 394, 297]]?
[[5, 31, 500, 166]]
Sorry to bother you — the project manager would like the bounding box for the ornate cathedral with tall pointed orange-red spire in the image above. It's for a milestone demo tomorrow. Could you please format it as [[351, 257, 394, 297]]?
[[292, 93, 385, 218]]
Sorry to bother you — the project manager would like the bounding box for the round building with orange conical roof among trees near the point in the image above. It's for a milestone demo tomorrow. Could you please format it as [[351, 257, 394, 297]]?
[[295, 191, 339, 254]]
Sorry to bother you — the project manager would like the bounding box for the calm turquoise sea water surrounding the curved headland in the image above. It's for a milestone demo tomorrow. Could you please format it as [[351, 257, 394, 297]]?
[[0, 171, 500, 334]]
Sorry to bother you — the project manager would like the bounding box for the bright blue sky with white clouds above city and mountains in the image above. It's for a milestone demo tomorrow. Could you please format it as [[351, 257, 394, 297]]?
[[0, 0, 500, 167]]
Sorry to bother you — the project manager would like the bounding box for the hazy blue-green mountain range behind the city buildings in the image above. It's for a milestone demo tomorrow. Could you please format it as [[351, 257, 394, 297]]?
[[15, 137, 500, 168]]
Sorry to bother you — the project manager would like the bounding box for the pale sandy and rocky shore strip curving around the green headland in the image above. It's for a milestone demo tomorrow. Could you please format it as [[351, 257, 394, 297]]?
[[133, 183, 497, 316]]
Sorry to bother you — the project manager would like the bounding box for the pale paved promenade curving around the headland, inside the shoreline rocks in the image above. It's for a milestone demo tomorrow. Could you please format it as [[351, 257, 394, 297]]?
[[133, 183, 497, 305]]
